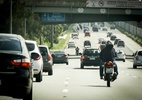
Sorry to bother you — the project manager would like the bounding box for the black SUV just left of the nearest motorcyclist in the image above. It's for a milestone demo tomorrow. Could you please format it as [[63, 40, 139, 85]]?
[[80, 48, 100, 69]]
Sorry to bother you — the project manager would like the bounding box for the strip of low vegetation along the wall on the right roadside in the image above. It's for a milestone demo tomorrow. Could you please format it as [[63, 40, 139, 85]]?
[[116, 26, 142, 46]]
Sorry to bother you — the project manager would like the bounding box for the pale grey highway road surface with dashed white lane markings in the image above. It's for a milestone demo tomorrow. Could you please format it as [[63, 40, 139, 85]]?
[[0, 23, 142, 100]]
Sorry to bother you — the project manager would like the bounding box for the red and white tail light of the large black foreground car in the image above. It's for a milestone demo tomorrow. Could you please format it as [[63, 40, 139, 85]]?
[[11, 58, 31, 68]]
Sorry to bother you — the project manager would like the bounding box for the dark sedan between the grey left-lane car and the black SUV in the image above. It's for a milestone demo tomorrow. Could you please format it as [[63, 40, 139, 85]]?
[[52, 50, 69, 65]]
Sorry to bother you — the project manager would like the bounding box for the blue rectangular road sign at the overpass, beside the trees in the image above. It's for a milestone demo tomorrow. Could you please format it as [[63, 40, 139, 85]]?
[[42, 13, 65, 22]]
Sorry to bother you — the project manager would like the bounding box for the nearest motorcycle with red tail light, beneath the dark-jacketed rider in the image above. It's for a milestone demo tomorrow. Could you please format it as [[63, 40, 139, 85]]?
[[103, 61, 117, 87]]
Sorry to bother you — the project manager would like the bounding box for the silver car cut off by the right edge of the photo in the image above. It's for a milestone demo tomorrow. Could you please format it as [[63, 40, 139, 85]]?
[[133, 50, 142, 68]]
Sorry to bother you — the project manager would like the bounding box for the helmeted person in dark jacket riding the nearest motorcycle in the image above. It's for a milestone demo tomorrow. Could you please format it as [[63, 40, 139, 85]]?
[[100, 42, 118, 80]]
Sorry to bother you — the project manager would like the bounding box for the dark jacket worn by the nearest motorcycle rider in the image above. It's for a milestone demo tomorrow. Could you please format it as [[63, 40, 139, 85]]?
[[100, 44, 115, 62]]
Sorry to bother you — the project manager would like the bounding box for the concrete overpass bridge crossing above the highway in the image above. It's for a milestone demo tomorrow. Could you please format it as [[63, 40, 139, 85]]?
[[26, 0, 142, 24]]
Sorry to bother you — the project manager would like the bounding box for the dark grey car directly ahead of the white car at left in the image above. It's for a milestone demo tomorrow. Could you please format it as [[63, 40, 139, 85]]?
[[38, 45, 53, 75]]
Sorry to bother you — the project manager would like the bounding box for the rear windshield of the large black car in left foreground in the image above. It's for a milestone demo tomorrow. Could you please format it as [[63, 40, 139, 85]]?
[[0, 36, 22, 51]]
